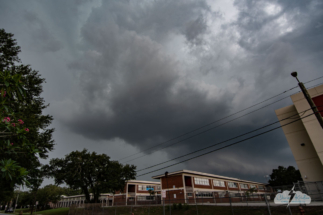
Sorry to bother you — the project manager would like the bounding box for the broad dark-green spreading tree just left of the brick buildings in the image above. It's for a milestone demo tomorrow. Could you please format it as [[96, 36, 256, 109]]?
[[45, 149, 136, 202]]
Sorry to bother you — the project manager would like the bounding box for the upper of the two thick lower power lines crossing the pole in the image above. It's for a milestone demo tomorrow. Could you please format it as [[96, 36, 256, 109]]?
[[136, 108, 311, 172]]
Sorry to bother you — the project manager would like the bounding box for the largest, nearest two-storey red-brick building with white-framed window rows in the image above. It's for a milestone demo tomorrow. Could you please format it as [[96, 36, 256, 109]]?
[[152, 170, 271, 203]]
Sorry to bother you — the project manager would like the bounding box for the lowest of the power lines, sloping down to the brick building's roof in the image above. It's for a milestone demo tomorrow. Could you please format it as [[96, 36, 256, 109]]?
[[137, 113, 314, 177]]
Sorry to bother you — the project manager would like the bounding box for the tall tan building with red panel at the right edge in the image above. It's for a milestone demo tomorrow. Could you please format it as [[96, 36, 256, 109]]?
[[275, 85, 323, 182]]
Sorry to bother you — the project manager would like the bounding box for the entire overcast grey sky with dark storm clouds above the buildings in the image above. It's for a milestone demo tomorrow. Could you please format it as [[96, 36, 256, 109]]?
[[0, 0, 323, 184]]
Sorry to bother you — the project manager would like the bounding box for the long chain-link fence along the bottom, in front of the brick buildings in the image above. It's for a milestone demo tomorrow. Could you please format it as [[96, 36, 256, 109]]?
[[69, 194, 323, 215]]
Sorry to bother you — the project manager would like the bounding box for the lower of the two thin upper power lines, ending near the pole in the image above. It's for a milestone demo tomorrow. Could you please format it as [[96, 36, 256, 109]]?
[[126, 96, 290, 163]]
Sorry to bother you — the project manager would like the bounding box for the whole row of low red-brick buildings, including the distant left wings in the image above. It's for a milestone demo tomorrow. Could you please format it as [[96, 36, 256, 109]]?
[[53, 170, 272, 207]]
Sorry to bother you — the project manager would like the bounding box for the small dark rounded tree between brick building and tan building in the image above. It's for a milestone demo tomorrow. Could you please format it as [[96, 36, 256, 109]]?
[[268, 166, 303, 186]]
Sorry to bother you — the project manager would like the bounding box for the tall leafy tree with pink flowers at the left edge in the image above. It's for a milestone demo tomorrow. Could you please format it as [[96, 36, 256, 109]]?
[[0, 29, 54, 200]]
